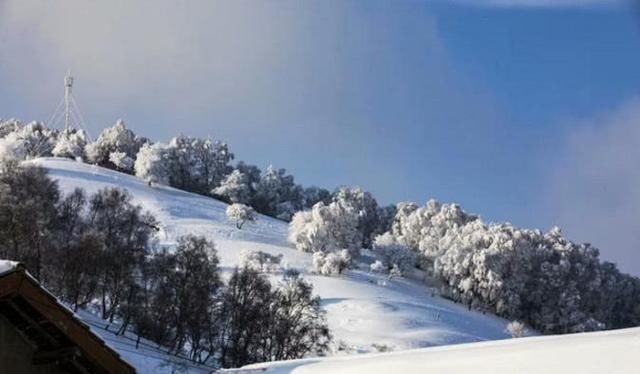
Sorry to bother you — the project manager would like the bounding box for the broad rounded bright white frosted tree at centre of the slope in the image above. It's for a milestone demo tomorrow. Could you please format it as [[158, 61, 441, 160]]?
[[289, 202, 361, 252]]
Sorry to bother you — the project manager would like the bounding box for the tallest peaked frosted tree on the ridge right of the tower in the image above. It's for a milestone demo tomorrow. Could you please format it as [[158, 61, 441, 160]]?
[[85, 120, 144, 173]]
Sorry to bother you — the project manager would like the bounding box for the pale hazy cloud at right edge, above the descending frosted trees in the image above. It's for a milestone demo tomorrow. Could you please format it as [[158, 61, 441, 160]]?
[[547, 98, 640, 275]]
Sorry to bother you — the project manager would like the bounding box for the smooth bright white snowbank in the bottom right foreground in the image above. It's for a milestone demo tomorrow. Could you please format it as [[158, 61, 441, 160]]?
[[242, 328, 640, 374]]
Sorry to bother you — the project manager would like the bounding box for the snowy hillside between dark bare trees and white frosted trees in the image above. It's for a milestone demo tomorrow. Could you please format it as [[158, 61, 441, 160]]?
[[31, 158, 507, 360]]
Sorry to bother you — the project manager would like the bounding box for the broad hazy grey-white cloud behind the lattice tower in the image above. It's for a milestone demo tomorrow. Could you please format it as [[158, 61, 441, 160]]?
[[0, 0, 499, 205]]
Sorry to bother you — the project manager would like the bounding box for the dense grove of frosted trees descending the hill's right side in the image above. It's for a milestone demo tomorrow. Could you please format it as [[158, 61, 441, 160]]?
[[384, 201, 640, 333]]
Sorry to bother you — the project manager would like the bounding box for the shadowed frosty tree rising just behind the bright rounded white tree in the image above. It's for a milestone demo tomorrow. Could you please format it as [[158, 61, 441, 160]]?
[[333, 187, 378, 248]]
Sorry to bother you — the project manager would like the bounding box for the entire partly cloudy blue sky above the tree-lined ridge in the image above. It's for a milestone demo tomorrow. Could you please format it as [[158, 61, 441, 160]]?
[[0, 0, 640, 274]]
